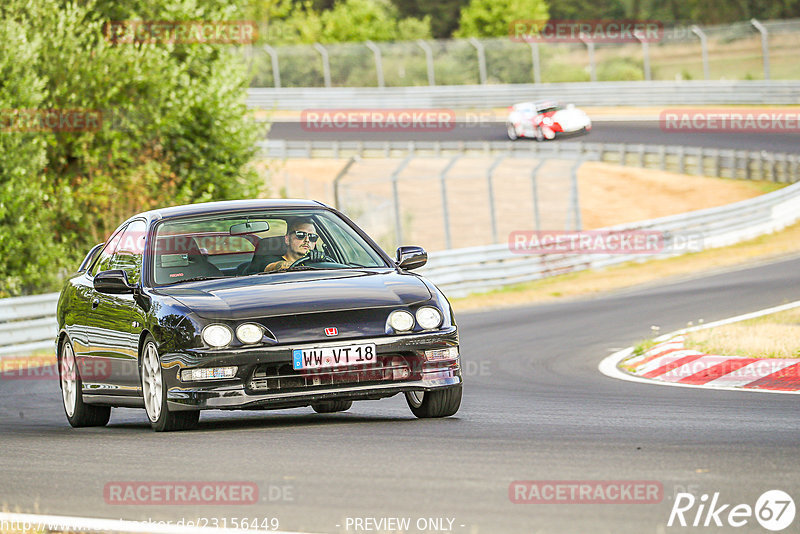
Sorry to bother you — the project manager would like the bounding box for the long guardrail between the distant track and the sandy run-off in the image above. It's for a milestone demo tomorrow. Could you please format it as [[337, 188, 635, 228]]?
[[258, 139, 800, 183]]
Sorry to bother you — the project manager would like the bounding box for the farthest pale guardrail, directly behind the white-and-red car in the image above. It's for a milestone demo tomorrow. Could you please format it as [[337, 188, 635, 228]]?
[[247, 80, 800, 110]]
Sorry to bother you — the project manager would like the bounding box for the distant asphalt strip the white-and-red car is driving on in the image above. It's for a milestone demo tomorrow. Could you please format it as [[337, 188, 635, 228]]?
[[268, 117, 800, 153]]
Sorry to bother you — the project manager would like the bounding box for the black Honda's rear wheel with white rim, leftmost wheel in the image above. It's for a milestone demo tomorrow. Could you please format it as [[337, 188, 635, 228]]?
[[58, 338, 111, 428]]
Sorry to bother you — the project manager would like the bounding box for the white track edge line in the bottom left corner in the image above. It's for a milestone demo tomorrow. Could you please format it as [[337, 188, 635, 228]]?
[[0, 512, 310, 534]]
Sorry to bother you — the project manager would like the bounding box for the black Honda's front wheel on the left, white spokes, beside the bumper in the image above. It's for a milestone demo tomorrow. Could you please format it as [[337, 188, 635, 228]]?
[[139, 336, 200, 432]]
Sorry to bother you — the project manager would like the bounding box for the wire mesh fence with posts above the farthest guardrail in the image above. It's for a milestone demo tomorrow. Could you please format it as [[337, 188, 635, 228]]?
[[244, 19, 800, 87]]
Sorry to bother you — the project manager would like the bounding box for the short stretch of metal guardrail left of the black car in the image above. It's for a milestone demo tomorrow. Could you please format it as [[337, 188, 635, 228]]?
[[0, 293, 58, 356]]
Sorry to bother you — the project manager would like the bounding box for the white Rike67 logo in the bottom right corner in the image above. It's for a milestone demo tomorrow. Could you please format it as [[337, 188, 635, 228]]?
[[667, 490, 796, 532]]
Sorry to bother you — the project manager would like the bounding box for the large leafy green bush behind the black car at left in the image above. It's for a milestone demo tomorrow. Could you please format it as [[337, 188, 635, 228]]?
[[0, 0, 259, 296]]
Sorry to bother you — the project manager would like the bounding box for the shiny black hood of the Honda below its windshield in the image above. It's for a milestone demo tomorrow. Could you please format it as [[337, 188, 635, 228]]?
[[158, 270, 432, 320]]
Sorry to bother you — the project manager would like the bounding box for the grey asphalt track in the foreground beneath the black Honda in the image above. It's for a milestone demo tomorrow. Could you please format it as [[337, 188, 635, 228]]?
[[0, 257, 800, 534]]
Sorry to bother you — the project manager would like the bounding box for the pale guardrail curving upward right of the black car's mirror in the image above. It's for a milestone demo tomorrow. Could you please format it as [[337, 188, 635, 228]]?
[[420, 183, 800, 297]]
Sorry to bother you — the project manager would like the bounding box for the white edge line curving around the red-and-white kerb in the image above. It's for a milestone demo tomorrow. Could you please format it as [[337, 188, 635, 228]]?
[[597, 300, 800, 395]]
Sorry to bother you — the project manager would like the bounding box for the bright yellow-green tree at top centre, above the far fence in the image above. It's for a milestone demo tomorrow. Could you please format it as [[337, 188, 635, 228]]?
[[454, 0, 549, 37]]
